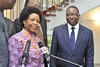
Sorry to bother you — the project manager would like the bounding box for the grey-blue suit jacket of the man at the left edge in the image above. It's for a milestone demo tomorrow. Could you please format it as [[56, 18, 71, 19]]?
[[0, 12, 8, 67]]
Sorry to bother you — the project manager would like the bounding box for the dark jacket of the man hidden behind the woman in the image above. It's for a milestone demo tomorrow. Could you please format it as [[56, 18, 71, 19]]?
[[14, 17, 48, 46]]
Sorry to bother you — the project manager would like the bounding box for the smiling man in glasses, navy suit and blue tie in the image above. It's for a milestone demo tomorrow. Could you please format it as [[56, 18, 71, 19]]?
[[50, 6, 94, 67]]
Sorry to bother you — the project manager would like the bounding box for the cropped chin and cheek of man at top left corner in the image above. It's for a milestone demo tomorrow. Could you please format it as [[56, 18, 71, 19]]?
[[0, 0, 16, 9]]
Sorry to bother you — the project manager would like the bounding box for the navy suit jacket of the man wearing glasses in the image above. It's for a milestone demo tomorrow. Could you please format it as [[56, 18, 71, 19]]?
[[50, 24, 94, 67]]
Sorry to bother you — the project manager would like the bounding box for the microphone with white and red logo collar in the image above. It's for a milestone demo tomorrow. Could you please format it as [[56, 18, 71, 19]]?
[[38, 42, 50, 62]]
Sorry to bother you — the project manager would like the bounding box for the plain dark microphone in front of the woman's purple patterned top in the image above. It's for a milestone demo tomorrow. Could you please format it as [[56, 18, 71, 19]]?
[[21, 40, 31, 67]]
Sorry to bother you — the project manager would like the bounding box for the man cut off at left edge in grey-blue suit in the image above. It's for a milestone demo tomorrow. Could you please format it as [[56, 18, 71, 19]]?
[[0, 0, 16, 67]]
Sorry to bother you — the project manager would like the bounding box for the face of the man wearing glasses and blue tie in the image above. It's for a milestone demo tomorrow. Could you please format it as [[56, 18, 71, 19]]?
[[66, 8, 80, 26]]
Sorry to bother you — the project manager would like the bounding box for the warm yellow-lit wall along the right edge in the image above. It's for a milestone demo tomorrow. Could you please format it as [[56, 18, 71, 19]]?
[[81, 7, 100, 64]]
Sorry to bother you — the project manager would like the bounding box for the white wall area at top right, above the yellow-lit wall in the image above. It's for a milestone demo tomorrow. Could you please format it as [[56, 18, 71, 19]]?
[[70, 0, 100, 14]]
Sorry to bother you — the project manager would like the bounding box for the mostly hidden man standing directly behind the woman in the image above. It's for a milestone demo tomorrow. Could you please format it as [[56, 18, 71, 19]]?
[[15, 0, 47, 46]]
